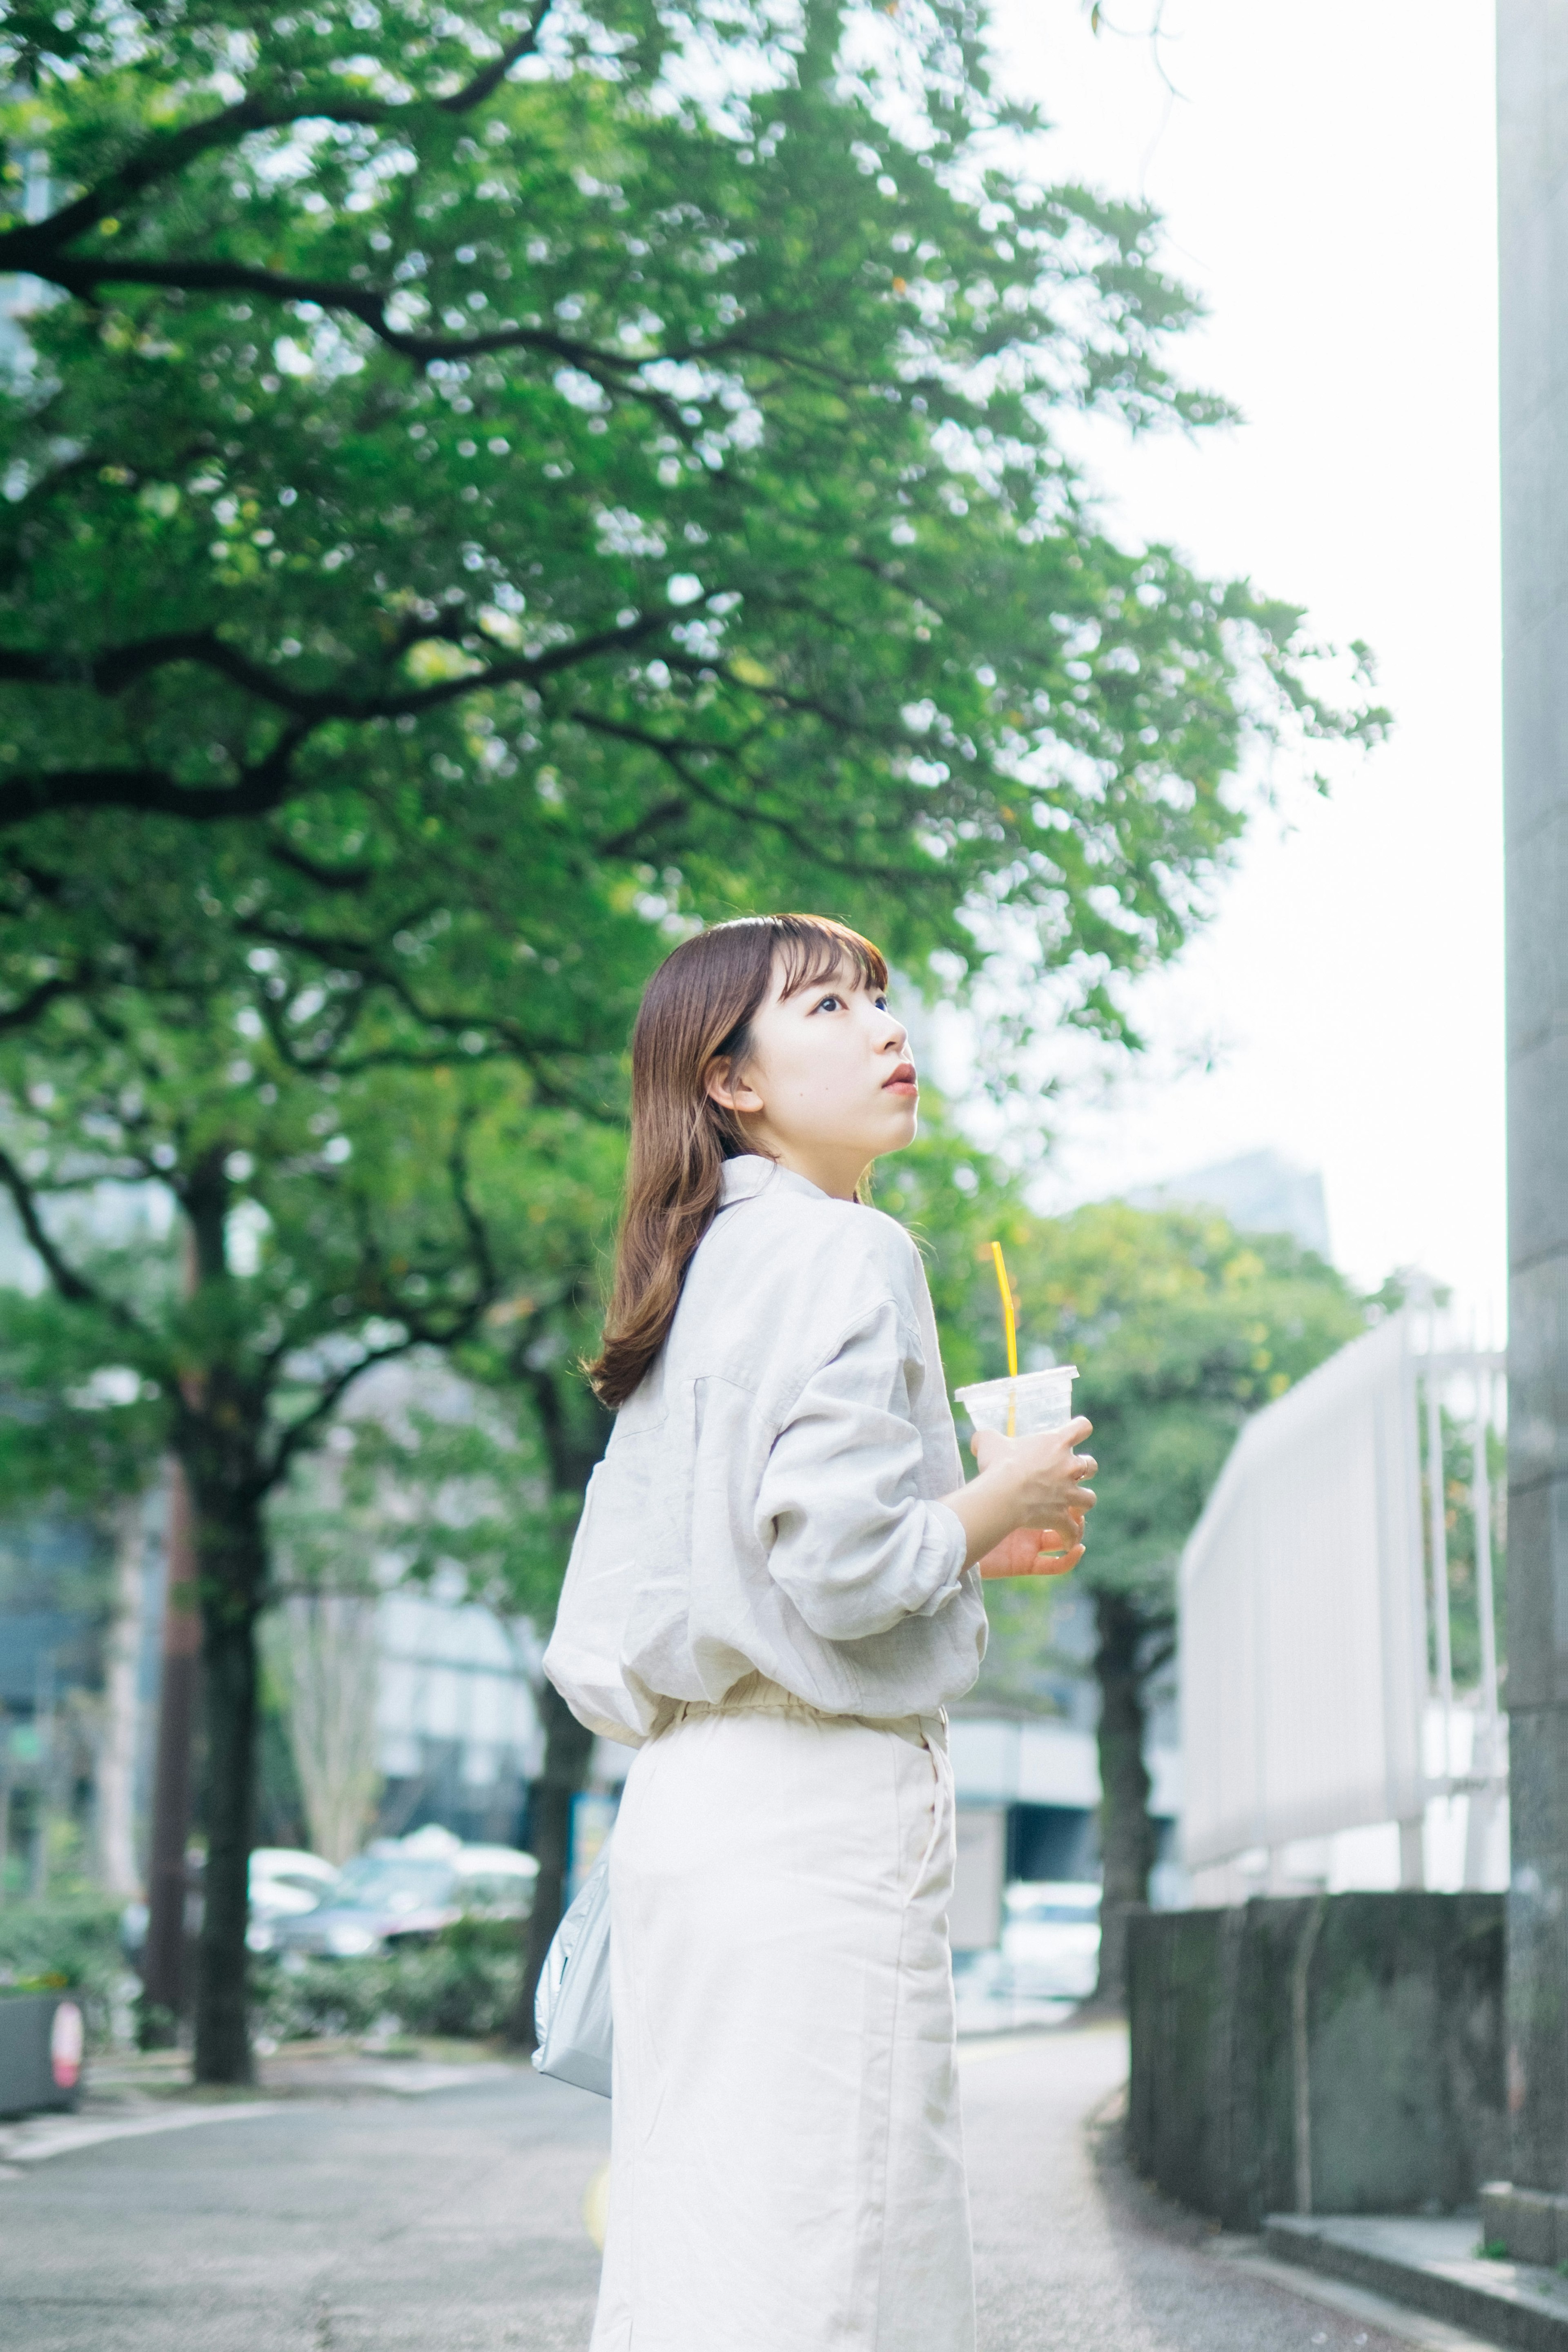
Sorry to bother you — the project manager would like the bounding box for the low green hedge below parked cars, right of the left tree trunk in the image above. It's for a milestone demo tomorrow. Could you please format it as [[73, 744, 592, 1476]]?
[[252, 1919, 522, 2042]]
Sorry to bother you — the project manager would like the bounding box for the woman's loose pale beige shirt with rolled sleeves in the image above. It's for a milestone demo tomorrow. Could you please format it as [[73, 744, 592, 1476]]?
[[546, 1157, 985, 1745]]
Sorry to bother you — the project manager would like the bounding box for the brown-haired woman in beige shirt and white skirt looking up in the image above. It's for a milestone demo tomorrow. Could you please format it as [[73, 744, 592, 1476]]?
[[546, 915, 1093, 2352]]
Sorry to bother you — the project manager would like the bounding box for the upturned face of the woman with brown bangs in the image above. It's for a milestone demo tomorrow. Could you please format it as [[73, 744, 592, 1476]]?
[[708, 967, 919, 1200]]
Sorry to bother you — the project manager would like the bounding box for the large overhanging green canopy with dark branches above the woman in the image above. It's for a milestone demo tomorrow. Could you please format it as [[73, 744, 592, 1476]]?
[[0, 0, 1380, 1007]]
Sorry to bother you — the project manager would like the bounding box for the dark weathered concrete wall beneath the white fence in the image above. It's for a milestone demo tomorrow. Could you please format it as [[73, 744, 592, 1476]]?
[[1128, 1893, 1507, 2230]]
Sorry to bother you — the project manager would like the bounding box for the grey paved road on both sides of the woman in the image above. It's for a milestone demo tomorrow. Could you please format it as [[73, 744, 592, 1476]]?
[[0, 2030, 1403, 2352]]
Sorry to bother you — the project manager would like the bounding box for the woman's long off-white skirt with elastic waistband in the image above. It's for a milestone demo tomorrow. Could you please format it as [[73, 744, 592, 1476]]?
[[592, 1677, 976, 2352]]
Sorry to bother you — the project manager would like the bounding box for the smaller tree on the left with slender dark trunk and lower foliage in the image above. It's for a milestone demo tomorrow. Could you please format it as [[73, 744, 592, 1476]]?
[[0, 927, 618, 2079]]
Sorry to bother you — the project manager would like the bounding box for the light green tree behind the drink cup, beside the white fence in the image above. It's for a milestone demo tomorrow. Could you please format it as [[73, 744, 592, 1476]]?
[[933, 1188, 1366, 2002]]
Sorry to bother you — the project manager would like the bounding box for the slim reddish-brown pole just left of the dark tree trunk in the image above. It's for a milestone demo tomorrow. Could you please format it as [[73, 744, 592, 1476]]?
[[141, 1458, 202, 2044]]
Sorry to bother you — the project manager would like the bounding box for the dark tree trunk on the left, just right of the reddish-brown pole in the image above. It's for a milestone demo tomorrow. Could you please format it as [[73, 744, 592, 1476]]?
[[195, 1482, 266, 2084]]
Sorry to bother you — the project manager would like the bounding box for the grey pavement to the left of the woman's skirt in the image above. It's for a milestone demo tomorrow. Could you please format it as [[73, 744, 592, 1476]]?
[[0, 2070, 609, 2352]]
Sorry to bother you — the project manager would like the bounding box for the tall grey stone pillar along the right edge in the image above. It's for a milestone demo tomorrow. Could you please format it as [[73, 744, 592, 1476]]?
[[1488, 0, 1568, 2237]]
